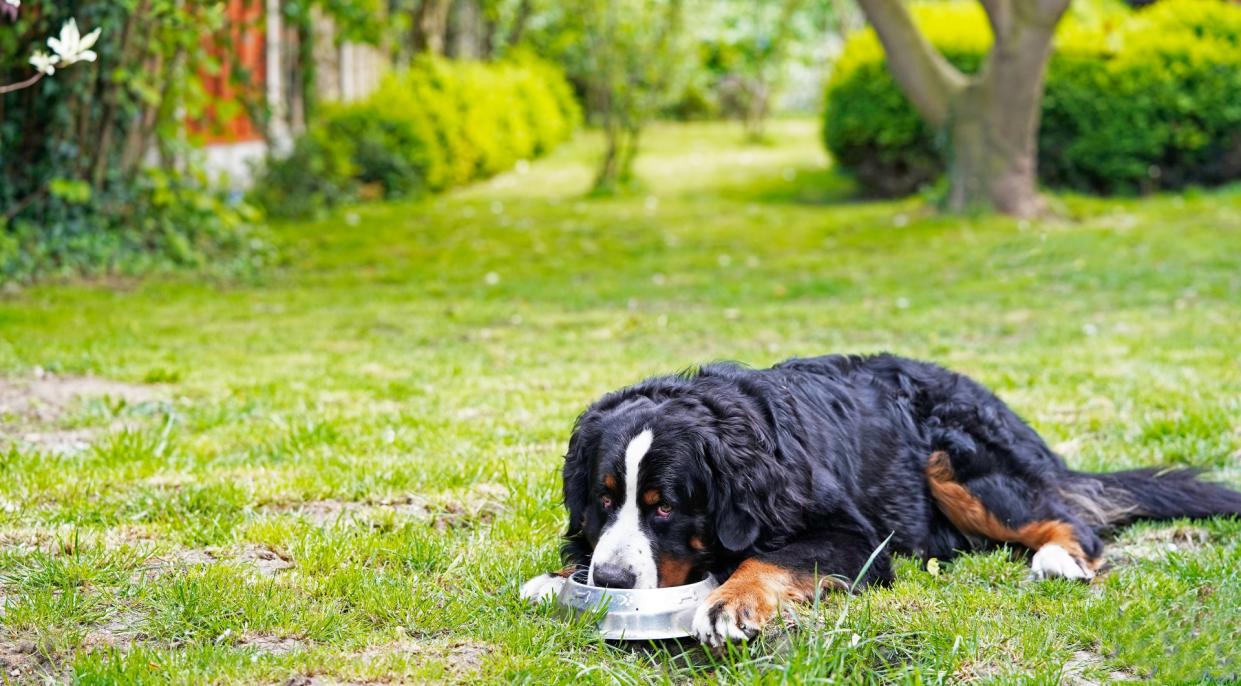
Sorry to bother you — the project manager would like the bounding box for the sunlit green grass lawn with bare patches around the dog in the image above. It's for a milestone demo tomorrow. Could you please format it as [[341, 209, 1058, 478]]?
[[0, 122, 1241, 685]]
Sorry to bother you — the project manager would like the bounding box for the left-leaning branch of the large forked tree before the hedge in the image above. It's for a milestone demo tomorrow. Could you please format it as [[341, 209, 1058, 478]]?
[[858, 0, 967, 128]]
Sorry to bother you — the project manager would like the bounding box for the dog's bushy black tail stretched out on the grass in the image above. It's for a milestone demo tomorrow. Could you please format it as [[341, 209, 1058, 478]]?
[[1060, 468, 1241, 528]]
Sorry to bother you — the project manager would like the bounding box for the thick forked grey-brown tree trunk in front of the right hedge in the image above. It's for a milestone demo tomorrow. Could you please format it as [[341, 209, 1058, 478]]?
[[859, 0, 1069, 216]]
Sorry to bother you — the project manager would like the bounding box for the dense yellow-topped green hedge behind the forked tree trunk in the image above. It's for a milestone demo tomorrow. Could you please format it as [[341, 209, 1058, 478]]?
[[823, 0, 1241, 195]]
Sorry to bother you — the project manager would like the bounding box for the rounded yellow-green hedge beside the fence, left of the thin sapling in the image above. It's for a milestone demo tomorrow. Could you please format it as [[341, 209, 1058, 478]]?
[[252, 56, 581, 216]]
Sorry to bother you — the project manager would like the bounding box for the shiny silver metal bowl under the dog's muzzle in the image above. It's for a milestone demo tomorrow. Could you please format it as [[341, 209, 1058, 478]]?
[[558, 569, 720, 641]]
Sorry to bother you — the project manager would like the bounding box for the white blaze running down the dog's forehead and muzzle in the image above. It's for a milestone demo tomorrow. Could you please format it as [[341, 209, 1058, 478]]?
[[587, 429, 659, 588]]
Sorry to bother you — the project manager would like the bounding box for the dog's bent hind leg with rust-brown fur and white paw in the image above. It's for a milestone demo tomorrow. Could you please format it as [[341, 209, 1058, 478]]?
[[926, 452, 1103, 581]]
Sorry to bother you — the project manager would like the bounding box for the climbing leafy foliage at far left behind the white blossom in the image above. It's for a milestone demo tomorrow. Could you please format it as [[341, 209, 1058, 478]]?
[[0, 0, 266, 279]]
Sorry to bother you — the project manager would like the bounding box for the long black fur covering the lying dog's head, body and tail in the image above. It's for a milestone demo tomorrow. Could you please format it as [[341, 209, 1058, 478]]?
[[563, 355, 1241, 595]]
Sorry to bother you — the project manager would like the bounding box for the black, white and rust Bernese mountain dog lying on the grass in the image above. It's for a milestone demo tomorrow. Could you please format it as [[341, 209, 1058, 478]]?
[[521, 355, 1241, 648]]
